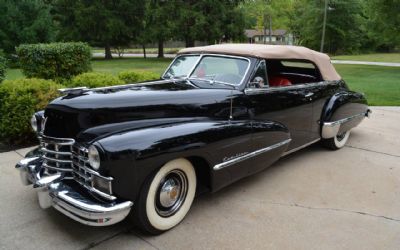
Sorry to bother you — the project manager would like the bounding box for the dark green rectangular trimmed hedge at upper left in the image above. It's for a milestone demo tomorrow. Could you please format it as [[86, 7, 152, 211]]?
[[16, 42, 92, 80]]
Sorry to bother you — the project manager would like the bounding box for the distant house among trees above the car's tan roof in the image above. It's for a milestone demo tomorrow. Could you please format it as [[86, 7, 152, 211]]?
[[245, 29, 294, 45]]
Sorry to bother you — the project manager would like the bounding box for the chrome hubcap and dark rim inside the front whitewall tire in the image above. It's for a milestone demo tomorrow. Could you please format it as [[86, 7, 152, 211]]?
[[155, 169, 188, 217]]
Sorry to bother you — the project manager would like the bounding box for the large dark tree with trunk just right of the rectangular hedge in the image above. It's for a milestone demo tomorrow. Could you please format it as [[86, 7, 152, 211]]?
[[51, 0, 145, 59]]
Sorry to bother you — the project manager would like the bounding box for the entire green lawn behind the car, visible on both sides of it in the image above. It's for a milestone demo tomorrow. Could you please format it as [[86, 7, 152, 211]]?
[[6, 58, 400, 106]]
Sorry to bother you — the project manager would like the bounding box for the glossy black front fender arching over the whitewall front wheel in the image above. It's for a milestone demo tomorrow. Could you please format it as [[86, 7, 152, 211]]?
[[98, 120, 252, 200]]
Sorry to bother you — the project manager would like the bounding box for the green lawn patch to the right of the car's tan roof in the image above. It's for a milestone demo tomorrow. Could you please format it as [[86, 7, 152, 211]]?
[[335, 64, 400, 106]]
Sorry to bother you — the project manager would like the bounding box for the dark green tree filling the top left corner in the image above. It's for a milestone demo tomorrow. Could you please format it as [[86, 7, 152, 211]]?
[[0, 0, 55, 54]]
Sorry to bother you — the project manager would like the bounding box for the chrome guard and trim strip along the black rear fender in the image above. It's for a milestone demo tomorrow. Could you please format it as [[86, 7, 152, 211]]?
[[321, 109, 372, 139]]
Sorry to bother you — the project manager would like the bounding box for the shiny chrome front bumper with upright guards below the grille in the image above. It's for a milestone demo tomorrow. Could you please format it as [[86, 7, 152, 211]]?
[[15, 157, 133, 226]]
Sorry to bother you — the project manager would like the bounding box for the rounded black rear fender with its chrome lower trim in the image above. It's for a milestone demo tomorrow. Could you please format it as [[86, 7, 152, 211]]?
[[320, 91, 371, 139]]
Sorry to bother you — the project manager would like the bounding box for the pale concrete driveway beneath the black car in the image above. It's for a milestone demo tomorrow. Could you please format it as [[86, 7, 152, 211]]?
[[0, 107, 400, 250]]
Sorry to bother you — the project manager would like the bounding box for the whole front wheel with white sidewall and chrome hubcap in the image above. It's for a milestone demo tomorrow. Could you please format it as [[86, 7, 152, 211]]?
[[134, 158, 196, 234]]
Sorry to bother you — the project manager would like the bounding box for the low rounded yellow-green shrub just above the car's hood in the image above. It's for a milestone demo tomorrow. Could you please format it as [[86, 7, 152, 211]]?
[[65, 72, 124, 88]]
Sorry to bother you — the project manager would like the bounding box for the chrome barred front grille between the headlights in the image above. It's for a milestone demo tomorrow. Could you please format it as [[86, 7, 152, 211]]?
[[39, 136, 116, 200]]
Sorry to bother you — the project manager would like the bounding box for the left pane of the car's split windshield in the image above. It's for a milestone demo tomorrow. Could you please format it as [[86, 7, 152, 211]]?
[[163, 55, 200, 78]]
